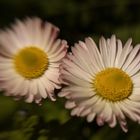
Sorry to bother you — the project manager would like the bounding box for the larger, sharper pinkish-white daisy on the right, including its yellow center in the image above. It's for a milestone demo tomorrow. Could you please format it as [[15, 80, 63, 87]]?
[[59, 35, 140, 132]]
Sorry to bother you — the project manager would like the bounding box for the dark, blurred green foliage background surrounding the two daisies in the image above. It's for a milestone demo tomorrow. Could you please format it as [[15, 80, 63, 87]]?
[[0, 0, 140, 140]]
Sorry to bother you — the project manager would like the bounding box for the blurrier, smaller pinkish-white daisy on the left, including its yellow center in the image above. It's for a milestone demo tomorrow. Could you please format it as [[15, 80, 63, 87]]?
[[0, 18, 67, 103]]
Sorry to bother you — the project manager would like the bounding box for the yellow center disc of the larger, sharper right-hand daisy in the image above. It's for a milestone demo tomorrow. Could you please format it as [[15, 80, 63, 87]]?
[[92, 68, 133, 102]]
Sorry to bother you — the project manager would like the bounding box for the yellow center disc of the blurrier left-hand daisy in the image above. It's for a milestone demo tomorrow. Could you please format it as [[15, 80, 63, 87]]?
[[13, 46, 48, 79]]
